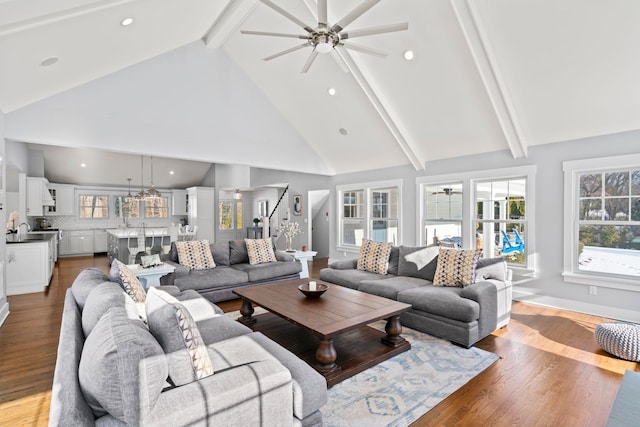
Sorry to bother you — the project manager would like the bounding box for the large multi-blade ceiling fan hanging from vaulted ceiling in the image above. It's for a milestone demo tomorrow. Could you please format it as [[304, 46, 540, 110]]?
[[240, 0, 409, 73]]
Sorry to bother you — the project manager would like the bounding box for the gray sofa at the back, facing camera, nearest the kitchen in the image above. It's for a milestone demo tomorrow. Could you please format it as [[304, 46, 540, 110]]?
[[160, 240, 302, 302]]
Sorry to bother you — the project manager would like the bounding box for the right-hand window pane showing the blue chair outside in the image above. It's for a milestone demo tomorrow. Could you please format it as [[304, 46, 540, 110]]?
[[473, 178, 527, 267]]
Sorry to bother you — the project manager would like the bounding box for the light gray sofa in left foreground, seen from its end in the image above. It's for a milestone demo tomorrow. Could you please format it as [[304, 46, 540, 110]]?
[[49, 269, 327, 426]]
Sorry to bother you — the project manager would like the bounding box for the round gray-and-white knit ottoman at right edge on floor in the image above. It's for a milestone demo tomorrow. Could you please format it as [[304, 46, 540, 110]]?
[[595, 322, 640, 362]]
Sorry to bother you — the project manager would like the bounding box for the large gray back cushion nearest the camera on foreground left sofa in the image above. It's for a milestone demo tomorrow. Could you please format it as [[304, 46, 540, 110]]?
[[78, 307, 168, 425]]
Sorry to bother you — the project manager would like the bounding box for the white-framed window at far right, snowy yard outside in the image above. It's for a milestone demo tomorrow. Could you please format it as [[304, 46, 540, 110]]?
[[564, 155, 640, 289]]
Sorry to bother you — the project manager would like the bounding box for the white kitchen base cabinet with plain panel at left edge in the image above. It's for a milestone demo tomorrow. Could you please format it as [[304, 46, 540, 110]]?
[[7, 240, 53, 295]]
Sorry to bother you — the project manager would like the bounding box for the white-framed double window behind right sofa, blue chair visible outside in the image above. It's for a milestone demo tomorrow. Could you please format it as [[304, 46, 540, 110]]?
[[416, 166, 536, 275]]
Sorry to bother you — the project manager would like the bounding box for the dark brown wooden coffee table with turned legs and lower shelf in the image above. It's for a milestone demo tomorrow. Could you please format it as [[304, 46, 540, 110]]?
[[233, 279, 411, 387]]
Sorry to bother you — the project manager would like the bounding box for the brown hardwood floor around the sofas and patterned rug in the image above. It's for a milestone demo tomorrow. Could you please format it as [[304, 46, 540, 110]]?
[[0, 256, 640, 426]]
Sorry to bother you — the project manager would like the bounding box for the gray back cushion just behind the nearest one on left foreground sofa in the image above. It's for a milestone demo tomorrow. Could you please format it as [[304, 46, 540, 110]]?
[[82, 282, 139, 337]]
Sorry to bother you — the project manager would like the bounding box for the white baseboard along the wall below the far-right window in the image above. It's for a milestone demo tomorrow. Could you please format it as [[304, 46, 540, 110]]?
[[513, 288, 640, 323]]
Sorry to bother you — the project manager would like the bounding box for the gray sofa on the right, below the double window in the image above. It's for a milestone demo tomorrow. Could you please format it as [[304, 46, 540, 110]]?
[[320, 246, 512, 347]]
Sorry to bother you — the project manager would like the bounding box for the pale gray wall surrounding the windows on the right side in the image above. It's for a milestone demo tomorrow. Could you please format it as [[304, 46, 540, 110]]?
[[330, 131, 640, 322]]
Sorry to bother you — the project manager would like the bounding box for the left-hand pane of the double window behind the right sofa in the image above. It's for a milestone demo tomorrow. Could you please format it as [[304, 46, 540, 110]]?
[[422, 182, 462, 247]]
